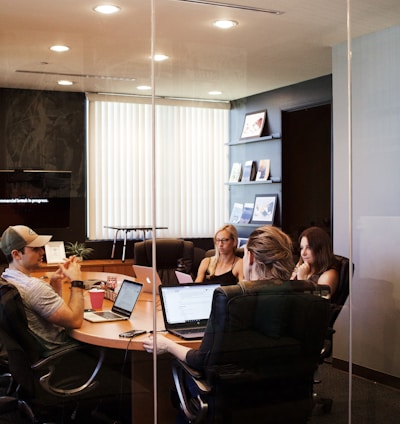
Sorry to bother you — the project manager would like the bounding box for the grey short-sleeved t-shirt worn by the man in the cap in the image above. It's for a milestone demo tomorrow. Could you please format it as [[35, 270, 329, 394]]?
[[2, 268, 71, 350]]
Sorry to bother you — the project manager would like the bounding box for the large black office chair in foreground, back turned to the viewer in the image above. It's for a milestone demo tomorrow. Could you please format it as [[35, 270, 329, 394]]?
[[172, 281, 329, 424]]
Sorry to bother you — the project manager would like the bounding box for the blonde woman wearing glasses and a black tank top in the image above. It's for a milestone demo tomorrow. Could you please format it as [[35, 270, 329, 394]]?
[[195, 224, 243, 286]]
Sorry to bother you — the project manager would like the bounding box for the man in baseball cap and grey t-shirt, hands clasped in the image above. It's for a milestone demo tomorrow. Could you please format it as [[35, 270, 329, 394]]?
[[0, 225, 84, 350]]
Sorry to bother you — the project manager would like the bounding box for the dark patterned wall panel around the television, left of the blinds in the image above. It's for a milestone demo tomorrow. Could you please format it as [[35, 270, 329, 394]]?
[[0, 88, 86, 241]]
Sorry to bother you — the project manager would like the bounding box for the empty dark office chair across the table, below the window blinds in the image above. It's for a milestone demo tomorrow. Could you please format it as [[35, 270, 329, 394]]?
[[133, 238, 194, 285]]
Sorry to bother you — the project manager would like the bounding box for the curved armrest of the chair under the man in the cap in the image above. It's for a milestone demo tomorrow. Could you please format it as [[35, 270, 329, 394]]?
[[31, 345, 105, 396]]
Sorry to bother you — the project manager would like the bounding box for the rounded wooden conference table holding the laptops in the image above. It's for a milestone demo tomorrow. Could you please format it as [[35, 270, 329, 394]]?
[[57, 272, 199, 424]]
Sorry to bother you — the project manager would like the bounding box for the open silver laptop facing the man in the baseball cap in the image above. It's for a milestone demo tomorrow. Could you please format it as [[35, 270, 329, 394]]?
[[83, 280, 143, 322]]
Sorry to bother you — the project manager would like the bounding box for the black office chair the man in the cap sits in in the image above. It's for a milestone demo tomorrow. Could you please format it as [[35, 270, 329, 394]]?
[[0, 283, 104, 423]]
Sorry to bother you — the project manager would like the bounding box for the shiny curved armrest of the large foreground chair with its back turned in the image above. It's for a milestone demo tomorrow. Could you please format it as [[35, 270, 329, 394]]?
[[172, 359, 211, 423]]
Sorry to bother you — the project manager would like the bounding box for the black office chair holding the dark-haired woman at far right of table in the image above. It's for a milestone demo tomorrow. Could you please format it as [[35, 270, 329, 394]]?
[[314, 255, 354, 413]]
